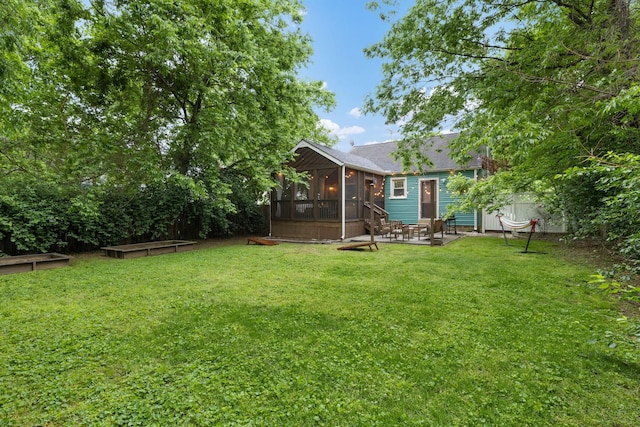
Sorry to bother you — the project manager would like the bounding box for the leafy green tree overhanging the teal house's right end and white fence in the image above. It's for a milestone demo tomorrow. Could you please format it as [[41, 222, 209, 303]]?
[[367, 0, 640, 260]]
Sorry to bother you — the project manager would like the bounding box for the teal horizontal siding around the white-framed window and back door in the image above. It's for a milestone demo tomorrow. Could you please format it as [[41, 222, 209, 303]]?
[[385, 170, 474, 226]]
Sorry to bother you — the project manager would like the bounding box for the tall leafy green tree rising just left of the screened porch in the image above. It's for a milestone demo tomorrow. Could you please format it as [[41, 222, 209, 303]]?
[[89, 0, 331, 188]]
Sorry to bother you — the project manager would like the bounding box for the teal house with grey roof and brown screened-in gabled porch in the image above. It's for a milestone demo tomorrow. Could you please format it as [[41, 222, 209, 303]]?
[[271, 135, 482, 240]]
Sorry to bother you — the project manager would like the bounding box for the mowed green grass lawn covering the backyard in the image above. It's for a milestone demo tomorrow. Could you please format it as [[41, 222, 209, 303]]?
[[0, 238, 640, 426]]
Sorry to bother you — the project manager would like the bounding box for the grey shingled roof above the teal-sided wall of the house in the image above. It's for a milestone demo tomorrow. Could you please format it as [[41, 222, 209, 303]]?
[[350, 133, 482, 173]]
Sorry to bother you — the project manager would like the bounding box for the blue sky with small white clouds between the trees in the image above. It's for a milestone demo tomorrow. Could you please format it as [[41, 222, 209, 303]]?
[[300, 0, 411, 151]]
